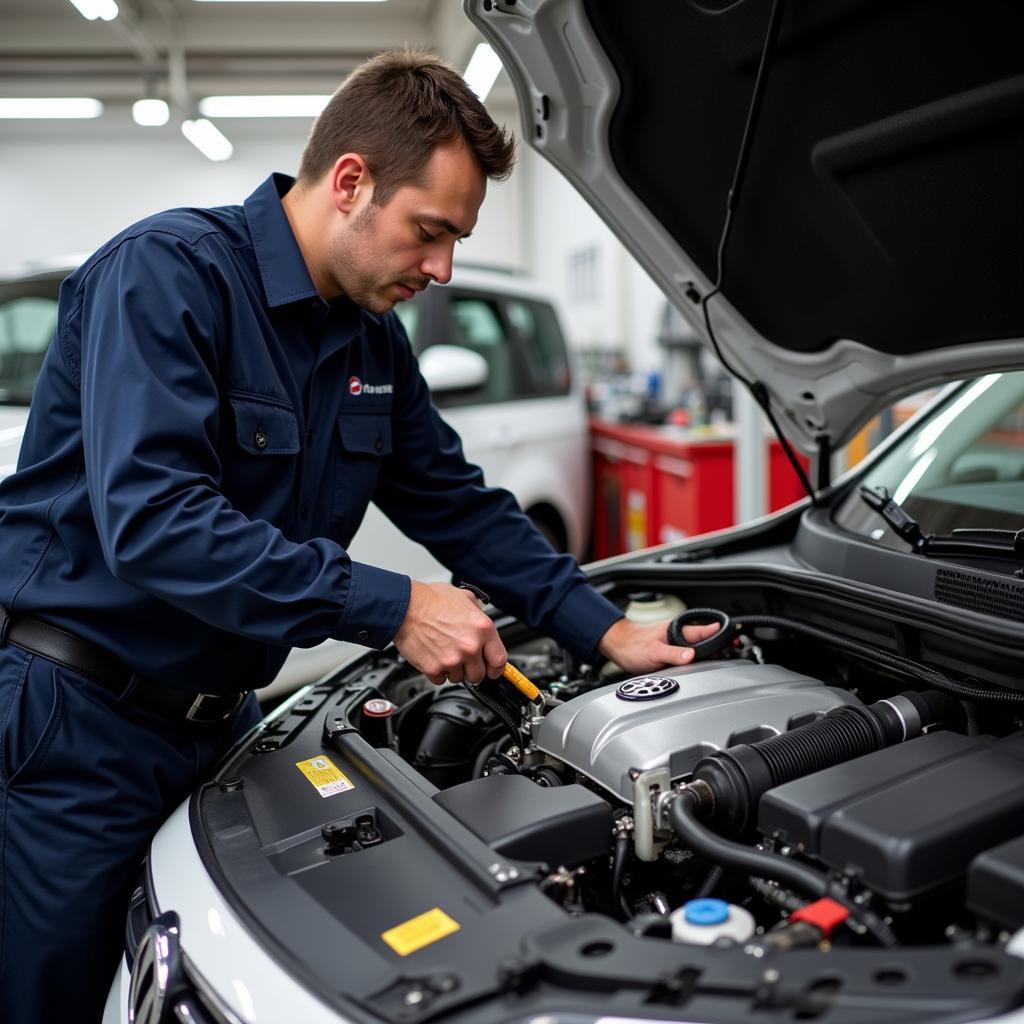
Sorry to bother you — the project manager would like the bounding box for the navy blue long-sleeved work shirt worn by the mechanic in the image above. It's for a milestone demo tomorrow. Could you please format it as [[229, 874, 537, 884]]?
[[0, 175, 621, 692]]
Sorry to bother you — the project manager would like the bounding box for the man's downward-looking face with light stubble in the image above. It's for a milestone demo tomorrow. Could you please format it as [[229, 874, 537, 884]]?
[[330, 142, 486, 313]]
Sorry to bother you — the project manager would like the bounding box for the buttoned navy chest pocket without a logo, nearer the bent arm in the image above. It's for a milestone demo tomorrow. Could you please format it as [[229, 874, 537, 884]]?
[[223, 395, 300, 525]]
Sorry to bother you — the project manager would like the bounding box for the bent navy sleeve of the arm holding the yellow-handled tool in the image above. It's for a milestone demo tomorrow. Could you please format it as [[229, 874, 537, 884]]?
[[73, 230, 410, 647]]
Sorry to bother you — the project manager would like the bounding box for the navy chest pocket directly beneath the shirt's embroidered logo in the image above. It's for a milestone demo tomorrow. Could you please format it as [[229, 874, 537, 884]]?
[[334, 410, 392, 546]]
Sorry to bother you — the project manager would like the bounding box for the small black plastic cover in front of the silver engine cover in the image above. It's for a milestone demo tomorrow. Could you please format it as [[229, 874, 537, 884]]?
[[434, 775, 611, 867]]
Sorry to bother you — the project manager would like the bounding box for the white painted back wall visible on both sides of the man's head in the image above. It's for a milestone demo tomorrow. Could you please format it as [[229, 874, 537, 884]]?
[[0, 106, 664, 371]]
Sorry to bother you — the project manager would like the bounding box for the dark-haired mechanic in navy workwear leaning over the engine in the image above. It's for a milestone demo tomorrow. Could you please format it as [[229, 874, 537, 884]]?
[[0, 50, 714, 1024]]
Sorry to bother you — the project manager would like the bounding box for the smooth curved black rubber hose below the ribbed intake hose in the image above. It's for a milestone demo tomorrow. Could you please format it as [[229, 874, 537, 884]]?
[[669, 790, 897, 946]]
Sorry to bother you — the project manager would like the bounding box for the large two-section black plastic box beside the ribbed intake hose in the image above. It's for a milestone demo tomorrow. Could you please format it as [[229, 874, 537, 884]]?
[[758, 732, 1024, 902]]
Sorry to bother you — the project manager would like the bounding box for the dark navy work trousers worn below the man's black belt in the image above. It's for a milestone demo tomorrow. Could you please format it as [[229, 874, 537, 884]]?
[[0, 644, 259, 1024]]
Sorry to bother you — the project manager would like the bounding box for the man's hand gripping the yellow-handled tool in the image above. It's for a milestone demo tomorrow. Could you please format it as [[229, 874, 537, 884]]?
[[394, 580, 508, 686]]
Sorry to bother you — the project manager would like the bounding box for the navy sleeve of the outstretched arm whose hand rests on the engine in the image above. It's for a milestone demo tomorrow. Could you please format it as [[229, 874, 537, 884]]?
[[374, 316, 623, 660]]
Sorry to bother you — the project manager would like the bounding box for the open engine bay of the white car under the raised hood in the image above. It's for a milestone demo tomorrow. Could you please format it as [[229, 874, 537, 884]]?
[[194, 584, 1024, 1021]]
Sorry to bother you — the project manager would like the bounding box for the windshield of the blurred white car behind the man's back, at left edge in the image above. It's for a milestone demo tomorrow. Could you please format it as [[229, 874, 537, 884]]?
[[0, 278, 60, 406]]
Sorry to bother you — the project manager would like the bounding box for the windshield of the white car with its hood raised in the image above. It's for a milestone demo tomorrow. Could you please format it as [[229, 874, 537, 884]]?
[[836, 373, 1024, 550]]
